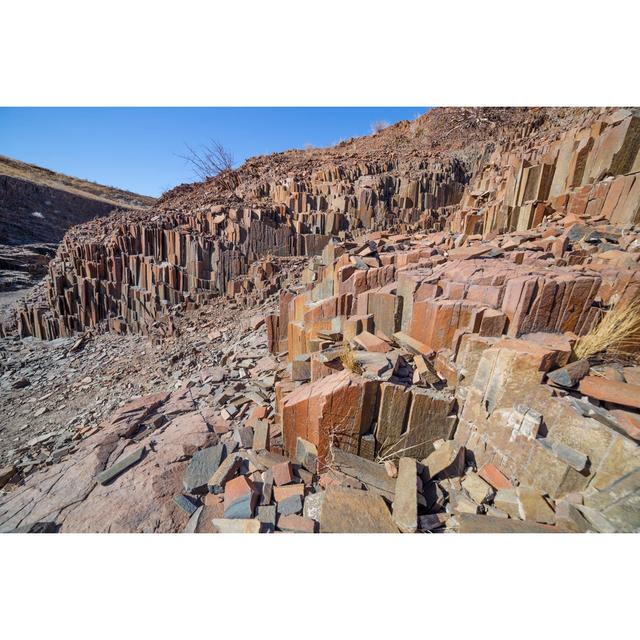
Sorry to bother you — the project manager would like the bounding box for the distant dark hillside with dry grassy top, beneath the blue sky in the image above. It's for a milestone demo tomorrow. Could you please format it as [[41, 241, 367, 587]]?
[[0, 156, 154, 292]]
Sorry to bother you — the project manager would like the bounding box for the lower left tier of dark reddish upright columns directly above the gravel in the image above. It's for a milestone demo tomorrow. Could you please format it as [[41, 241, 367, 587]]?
[[19, 206, 328, 339]]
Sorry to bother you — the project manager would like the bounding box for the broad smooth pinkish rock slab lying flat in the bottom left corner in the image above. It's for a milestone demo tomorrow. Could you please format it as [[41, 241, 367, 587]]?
[[0, 398, 215, 533]]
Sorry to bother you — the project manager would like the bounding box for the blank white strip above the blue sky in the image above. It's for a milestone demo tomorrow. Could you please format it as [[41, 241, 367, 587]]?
[[0, 0, 639, 106]]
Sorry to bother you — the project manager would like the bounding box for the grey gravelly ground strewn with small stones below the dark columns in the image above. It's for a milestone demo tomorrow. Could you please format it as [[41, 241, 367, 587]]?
[[0, 292, 278, 477]]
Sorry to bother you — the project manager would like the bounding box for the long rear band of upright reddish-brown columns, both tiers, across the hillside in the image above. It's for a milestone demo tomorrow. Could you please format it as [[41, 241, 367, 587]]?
[[18, 148, 468, 339]]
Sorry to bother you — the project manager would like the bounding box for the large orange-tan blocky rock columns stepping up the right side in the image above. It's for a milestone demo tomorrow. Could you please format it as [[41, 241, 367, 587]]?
[[264, 111, 640, 526]]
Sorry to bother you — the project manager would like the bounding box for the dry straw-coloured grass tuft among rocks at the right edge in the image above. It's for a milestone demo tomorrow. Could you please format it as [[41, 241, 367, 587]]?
[[574, 298, 640, 361]]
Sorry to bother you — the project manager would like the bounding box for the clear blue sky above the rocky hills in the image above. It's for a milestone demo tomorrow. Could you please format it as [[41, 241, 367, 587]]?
[[0, 107, 427, 196]]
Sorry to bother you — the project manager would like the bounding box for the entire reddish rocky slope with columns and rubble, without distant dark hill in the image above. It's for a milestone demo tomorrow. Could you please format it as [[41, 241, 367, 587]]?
[[0, 108, 640, 532]]
